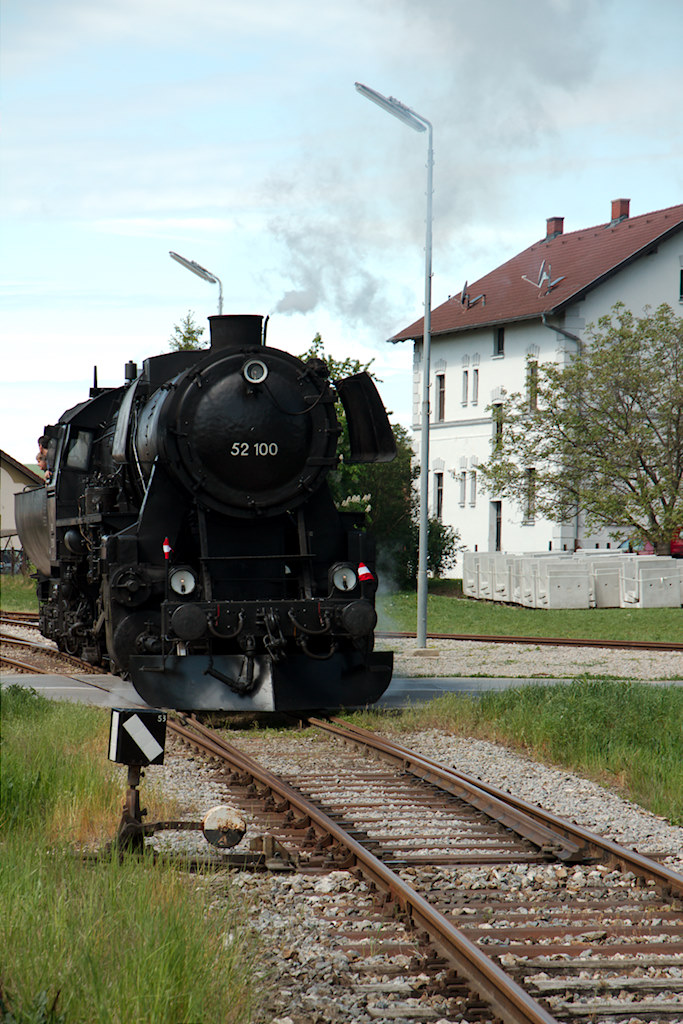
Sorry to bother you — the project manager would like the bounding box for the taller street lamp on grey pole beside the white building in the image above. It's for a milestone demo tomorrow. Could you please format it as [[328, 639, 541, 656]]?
[[355, 82, 434, 649]]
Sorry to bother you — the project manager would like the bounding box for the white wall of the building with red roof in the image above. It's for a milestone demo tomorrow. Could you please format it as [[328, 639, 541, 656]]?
[[413, 232, 683, 574]]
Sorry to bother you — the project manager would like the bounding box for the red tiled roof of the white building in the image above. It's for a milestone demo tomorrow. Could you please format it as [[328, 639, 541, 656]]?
[[389, 201, 683, 342]]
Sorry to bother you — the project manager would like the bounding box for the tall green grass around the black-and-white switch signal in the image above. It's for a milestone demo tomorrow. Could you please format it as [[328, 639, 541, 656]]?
[[0, 686, 257, 1024]]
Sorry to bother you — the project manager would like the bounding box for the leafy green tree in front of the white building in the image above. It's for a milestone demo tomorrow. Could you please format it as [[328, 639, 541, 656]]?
[[481, 303, 683, 553]]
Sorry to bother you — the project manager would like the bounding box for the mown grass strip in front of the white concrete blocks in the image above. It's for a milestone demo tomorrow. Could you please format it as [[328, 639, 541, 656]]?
[[377, 585, 683, 641]]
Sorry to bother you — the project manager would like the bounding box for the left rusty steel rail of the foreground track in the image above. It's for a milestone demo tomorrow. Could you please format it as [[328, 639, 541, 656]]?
[[167, 717, 557, 1024]]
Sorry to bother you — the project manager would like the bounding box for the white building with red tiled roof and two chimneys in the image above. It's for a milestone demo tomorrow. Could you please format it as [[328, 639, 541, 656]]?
[[391, 199, 683, 552]]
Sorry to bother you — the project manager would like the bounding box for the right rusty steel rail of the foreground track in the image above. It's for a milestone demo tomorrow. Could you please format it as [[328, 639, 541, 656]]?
[[323, 718, 683, 896]]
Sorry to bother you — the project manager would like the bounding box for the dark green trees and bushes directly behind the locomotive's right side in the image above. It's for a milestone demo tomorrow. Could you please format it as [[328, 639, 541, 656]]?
[[300, 334, 459, 588]]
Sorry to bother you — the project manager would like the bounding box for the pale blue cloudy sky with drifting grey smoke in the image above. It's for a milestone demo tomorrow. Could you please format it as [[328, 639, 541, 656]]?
[[0, 0, 683, 462]]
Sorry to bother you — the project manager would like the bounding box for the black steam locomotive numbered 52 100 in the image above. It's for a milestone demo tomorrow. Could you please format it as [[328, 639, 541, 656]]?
[[16, 315, 395, 712]]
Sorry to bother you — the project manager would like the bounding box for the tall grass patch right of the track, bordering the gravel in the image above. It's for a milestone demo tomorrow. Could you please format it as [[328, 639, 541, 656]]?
[[354, 677, 683, 825]]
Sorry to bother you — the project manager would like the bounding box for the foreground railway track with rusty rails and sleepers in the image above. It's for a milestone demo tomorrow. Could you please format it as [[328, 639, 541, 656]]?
[[166, 720, 683, 1024]]
